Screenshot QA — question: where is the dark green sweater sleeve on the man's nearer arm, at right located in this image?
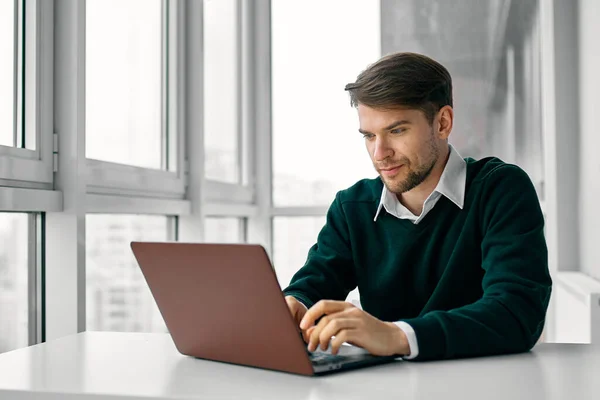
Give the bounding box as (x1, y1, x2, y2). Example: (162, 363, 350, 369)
(404, 165, 552, 360)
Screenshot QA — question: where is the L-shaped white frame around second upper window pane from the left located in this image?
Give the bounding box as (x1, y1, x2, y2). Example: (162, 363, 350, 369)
(80, 0, 187, 199)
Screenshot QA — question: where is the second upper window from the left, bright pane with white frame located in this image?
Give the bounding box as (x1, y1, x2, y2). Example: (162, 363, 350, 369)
(79, 0, 186, 199)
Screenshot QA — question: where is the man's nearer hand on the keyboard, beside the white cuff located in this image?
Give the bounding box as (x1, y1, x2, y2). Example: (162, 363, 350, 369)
(298, 300, 410, 356)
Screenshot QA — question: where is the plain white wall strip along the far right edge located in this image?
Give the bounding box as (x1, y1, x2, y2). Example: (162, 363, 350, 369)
(576, 0, 600, 279)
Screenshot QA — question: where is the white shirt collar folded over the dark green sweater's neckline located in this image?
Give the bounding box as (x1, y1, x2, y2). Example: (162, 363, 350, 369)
(373, 145, 467, 221)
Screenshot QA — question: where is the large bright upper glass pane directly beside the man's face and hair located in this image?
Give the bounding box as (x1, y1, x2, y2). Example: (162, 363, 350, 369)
(271, 0, 380, 206)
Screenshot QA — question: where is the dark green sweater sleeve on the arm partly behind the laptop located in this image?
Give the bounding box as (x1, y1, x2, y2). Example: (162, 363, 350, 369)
(283, 193, 356, 308)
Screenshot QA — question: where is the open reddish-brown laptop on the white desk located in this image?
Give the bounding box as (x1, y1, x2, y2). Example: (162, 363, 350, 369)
(131, 242, 397, 376)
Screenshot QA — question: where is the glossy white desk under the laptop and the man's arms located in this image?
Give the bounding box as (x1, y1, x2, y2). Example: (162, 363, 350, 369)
(0, 332, 600, 400)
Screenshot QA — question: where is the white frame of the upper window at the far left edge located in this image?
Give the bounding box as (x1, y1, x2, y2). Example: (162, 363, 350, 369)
(0, 0, 54, 189)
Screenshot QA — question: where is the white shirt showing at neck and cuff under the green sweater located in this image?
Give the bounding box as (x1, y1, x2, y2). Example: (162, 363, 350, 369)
(373, 145, 467, 360)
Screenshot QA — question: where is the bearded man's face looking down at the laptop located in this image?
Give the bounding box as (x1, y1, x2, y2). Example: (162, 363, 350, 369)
(358, 104, 441, 194)
